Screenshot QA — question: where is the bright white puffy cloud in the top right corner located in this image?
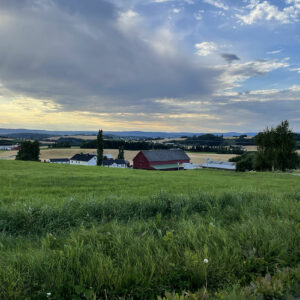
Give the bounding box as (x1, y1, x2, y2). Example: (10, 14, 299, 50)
(236, 0, 300, 25)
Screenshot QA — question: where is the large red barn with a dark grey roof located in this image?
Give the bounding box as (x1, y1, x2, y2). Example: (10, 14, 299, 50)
(133, 149, 190, 170)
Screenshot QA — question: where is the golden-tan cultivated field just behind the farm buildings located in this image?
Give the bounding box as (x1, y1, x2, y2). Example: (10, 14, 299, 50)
(0, 148, 235, 164)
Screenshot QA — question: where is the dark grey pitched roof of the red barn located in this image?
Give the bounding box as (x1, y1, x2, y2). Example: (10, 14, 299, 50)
(141, 149, 190, 162)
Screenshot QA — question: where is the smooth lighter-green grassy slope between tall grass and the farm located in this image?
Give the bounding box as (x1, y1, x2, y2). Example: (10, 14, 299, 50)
(0, 160, 300, 205)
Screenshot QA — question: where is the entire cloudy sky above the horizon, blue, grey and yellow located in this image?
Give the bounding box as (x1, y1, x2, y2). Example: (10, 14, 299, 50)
(0, 0, 300, 132)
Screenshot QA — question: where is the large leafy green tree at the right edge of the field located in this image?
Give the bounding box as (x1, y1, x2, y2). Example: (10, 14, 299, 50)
(255, 120, 298, 171)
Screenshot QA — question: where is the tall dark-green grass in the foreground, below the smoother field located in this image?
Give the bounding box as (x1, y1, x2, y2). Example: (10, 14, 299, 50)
(0, 192, 300, 299)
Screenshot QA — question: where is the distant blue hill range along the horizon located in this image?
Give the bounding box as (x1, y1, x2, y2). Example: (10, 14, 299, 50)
(0, 128, 257, 139)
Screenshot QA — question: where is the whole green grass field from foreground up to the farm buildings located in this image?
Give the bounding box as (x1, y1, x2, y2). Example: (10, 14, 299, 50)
(0, 160, 300, 300)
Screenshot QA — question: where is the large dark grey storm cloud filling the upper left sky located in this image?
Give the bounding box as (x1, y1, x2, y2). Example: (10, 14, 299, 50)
(0, 0, 221, 111)
